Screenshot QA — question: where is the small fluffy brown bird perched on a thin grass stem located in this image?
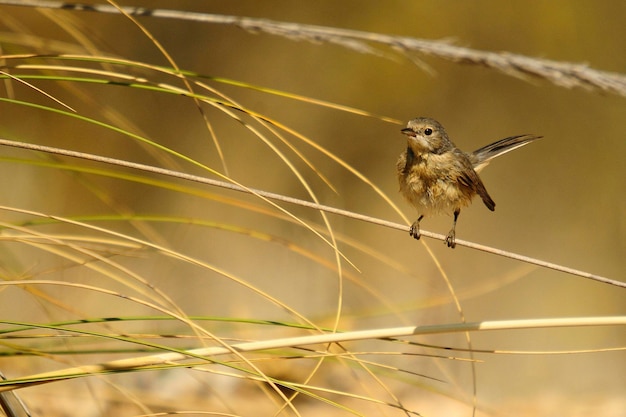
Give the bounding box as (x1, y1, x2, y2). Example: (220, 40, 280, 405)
(396, 117, 542, 248)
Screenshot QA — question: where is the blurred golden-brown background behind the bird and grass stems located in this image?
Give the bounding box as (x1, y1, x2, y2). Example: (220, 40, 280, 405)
(0, 0, 626, 416)
